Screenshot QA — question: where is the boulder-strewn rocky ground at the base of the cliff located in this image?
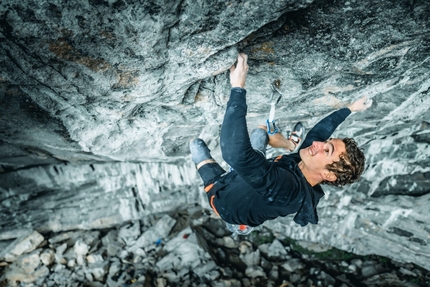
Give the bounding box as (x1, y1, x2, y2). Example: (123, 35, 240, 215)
(0, 205, 430, 287)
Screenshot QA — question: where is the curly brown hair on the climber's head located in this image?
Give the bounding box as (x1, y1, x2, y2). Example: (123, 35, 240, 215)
(321, 138, 366, 186)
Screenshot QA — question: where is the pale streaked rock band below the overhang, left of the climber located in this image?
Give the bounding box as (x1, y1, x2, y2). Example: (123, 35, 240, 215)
(0, 163, 206, 240)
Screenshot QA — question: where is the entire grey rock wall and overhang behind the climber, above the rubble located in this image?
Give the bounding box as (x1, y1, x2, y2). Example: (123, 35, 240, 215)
(0, 0, 430, 274)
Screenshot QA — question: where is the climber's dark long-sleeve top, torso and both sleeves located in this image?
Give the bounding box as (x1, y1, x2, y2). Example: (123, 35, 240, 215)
(214, 88, 351, 226)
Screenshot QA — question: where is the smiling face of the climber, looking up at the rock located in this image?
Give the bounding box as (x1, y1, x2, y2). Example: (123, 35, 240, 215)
(300, 139, 346, 180)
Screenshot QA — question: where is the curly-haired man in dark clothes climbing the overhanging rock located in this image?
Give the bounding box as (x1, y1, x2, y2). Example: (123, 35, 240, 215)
(190, 54, 371, 230)
